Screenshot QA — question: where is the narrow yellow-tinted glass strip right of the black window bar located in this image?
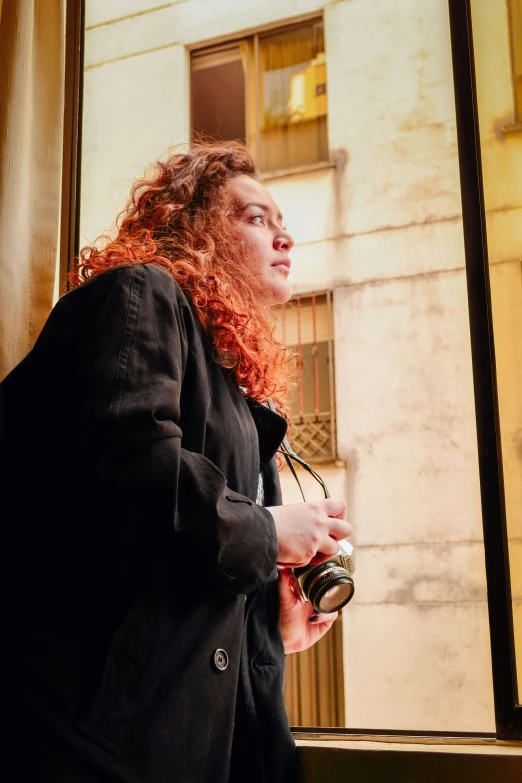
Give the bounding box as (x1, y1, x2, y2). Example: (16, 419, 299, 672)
(471, 0, 522, 698)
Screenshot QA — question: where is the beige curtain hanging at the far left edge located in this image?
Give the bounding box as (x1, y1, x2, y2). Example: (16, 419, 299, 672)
(0, 0, 66, 379)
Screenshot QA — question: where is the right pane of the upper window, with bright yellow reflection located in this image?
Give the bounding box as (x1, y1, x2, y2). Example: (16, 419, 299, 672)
(259, 22, 328, 171)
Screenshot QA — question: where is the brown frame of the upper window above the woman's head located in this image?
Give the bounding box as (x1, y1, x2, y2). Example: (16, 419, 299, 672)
(187, 12, 332, 179)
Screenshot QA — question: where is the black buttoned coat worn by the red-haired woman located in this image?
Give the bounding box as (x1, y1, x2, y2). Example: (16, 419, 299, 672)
(1, 265, 295, 783)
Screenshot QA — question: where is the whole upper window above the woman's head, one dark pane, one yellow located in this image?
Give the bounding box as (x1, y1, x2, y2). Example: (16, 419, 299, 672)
(191, 19, 328, 171)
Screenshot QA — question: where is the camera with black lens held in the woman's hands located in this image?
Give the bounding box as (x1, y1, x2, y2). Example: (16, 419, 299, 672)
(293, 539, 355, 613)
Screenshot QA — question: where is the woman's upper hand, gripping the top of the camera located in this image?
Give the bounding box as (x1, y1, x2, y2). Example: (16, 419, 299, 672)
(267, 498, 352, 568)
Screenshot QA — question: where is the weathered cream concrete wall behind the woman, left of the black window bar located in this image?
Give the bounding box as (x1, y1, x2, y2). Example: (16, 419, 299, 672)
(82, 0, 494, 731)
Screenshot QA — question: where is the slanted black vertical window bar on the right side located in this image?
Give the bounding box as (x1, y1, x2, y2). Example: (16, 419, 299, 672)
(448, 0, 522, 740)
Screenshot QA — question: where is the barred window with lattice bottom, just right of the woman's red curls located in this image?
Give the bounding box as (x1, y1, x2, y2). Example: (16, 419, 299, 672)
(278, 291, 336, 462)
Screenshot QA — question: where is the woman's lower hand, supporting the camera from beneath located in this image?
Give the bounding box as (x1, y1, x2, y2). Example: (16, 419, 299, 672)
(279, 568, 338, 653)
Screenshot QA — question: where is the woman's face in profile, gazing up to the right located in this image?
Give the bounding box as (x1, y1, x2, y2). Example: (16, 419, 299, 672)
(225, 174, 294, 306)
